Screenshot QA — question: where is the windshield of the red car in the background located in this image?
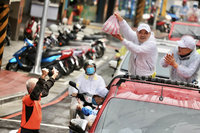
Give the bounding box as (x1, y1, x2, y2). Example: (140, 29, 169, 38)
(171, 24, 200, 40)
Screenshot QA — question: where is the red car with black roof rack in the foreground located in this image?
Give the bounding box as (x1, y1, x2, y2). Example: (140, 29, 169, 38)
(89, 75, 200, 133)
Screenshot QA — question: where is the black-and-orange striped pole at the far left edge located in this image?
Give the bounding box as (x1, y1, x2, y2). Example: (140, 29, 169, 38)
(0, 0, 9, 70)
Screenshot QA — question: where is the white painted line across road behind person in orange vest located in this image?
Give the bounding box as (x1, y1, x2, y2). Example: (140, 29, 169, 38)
(0, 118, 69, 129)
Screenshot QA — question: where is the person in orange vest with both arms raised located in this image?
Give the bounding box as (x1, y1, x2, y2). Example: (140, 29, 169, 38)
(17, 68, 58, 133)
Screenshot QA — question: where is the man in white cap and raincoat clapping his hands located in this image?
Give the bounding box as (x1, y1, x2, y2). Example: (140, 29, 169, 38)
(161, 35, 200, 83)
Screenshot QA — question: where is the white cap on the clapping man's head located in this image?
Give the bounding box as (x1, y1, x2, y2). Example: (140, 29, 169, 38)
(177, 35, 196, 50)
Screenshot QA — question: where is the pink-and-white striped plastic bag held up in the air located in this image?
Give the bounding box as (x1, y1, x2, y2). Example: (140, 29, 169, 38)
(102, 15, 119, 35)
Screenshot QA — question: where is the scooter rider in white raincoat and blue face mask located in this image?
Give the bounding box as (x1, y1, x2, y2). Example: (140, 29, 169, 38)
(69, 60, 108, 119)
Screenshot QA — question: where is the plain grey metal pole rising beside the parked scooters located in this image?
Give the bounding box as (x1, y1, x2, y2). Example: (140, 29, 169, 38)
(30, 0, 49, 75)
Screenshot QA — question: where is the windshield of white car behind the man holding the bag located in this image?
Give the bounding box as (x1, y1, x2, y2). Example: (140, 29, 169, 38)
(121, 52, 170, 78)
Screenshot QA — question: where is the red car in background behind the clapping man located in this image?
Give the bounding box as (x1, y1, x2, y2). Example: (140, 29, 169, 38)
(168, 22, 200, 47)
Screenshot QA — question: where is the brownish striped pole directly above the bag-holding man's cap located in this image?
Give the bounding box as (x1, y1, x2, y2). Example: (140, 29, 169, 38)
(133, 0, 145, 27)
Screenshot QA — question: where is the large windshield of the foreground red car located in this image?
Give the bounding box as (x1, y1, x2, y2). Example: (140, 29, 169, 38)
(95, 98, 200, 133)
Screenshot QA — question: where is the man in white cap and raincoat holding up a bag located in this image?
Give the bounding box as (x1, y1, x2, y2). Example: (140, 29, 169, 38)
(113, 13, 158, 76)
